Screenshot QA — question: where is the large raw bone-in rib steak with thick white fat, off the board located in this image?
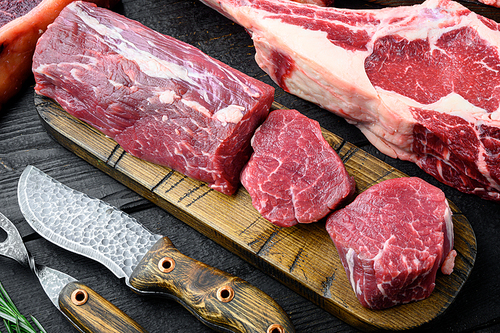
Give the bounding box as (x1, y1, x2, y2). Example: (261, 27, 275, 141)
(202, 0, 500, 200)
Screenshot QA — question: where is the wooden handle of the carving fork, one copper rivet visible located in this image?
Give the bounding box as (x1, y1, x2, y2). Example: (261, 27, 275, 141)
(59, 282, 147, 333)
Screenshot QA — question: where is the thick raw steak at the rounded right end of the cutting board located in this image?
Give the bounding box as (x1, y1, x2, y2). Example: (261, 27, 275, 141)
(326, 177, 456, 309)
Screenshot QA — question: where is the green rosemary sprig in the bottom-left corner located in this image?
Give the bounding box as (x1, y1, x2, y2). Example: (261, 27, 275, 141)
(0, 282, 47, 333)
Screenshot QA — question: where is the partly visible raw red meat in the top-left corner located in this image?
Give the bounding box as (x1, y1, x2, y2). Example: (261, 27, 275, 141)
(0, 0, 119, 111)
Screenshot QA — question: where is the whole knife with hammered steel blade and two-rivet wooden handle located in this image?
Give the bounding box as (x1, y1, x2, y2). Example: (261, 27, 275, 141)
(18, 166, 295, 333)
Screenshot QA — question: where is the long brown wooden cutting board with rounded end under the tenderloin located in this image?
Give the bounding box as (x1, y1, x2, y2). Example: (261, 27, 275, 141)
(35, 94, 476, 331)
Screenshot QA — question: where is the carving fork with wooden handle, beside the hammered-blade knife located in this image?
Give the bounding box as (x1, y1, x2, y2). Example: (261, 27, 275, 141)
(0, 213, 147, 333)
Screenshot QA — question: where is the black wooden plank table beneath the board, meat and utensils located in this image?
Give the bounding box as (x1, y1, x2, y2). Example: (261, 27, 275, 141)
(0, 0, 500, 333)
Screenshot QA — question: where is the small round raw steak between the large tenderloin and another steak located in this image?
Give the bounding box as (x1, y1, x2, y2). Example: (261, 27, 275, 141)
(241, 110, 355, 227)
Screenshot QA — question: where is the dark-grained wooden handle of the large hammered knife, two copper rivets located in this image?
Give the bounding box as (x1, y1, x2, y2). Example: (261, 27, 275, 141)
(129, 237, 295, 333)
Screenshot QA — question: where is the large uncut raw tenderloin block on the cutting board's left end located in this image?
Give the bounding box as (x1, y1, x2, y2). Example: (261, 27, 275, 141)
(33, 2, 274, 194)
